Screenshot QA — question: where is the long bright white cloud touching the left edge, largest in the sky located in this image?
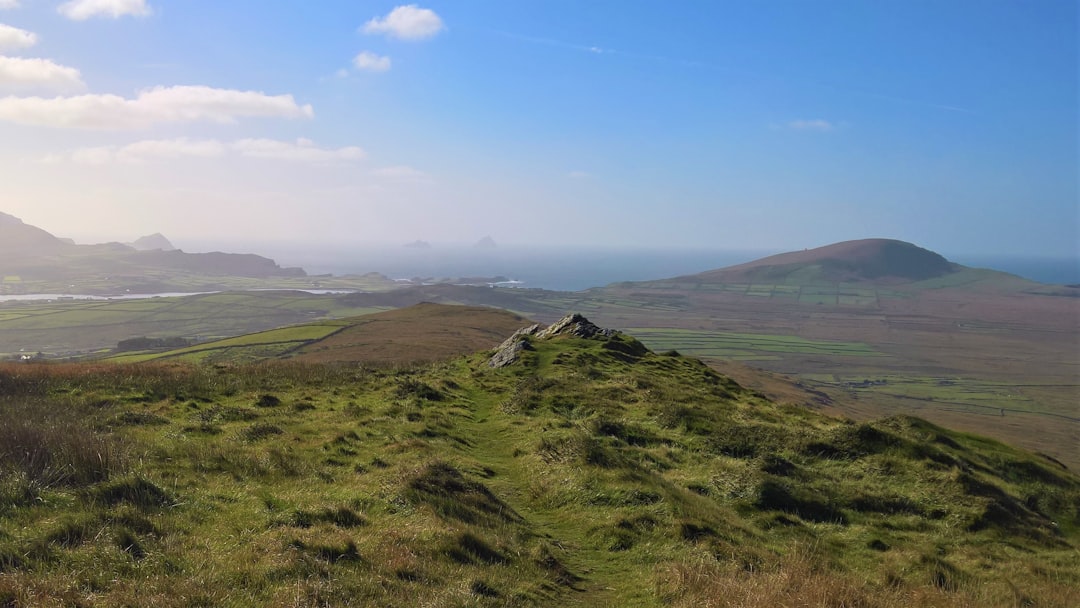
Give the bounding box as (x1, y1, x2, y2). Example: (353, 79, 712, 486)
(0, 85, 314, 129)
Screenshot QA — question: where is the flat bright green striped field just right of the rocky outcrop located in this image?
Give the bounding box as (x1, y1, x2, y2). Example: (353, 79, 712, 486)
(626, 327, 883, 361)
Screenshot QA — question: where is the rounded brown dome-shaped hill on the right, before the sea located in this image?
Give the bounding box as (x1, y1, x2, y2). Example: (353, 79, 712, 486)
(693, 239, 963, 283)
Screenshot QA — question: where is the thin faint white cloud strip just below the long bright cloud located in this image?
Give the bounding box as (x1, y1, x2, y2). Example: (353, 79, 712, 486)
(54, 137, 366, 165)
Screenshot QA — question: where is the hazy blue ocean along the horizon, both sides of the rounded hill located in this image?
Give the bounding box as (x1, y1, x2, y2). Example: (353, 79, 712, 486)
(256, 245, 1080, 292)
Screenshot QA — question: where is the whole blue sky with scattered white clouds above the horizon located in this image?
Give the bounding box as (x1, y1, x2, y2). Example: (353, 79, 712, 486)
(0, 0, 1080, 257)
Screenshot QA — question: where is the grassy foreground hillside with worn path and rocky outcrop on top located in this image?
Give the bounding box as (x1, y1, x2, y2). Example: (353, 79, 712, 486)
(0, 316, 1080, 608)
